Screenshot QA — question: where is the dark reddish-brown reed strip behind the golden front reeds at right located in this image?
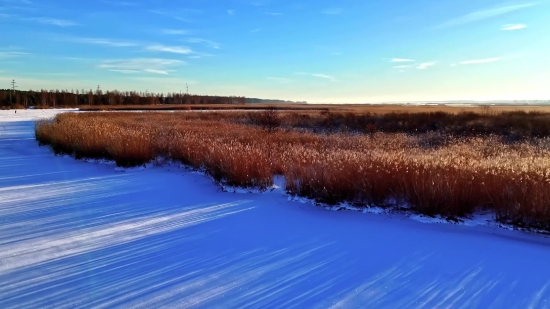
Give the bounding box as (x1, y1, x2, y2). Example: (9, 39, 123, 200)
(281, 109, 550, 137)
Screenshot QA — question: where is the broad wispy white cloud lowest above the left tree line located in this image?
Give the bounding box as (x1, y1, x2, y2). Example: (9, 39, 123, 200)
(97, 58, 185, 75)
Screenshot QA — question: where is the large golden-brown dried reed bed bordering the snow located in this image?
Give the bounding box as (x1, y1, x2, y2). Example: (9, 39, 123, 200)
(36, 113, 550, 230)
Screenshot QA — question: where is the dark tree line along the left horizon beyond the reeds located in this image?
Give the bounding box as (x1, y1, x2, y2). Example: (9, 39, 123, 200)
(0, 89, 246, 107)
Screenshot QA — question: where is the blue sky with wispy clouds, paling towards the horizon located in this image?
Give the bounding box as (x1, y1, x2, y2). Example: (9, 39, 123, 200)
(0, 0, 550, 103)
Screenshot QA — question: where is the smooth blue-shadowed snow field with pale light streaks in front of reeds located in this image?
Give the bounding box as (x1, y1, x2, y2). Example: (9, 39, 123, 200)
(0, 110, 550, 309)
